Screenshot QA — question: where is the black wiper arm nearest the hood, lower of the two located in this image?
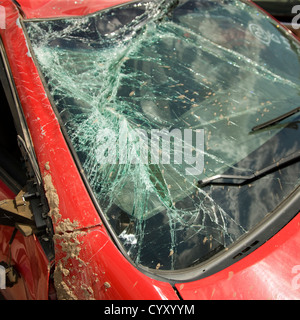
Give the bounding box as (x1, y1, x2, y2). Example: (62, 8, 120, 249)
(197, 151, 300, 188)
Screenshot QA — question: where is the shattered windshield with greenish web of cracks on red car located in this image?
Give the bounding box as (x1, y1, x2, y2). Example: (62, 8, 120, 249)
(24, 0, 300, 270)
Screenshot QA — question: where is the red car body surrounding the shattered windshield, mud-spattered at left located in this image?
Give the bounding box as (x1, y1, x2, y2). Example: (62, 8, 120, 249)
(0, 0, 300, 300)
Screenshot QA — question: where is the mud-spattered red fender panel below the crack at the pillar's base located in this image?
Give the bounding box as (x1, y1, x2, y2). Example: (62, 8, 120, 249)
(55, 227, 178, 300)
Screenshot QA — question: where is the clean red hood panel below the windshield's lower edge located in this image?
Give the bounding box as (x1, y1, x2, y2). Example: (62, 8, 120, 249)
(176, 214, 300, 300)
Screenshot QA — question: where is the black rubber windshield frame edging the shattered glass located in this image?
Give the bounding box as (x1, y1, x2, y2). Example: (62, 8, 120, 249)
(20, 0, 300, 283)
